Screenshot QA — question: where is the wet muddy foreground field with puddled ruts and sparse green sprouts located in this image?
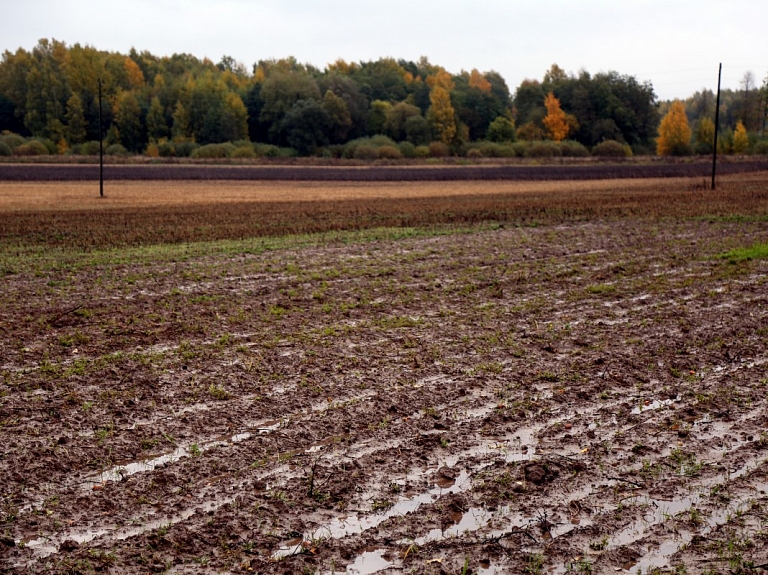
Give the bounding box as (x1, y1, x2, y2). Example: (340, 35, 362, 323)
(0, 178, 768, 574)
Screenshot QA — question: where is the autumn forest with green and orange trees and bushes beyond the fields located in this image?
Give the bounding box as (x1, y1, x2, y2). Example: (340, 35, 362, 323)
(0, 39, 768, 160)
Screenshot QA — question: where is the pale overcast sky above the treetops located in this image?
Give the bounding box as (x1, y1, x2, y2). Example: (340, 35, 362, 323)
(0, 0, 768, 99)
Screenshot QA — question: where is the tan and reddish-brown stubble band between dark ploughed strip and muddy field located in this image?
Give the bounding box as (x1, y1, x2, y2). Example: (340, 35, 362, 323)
(0, 172, 768, 249)
